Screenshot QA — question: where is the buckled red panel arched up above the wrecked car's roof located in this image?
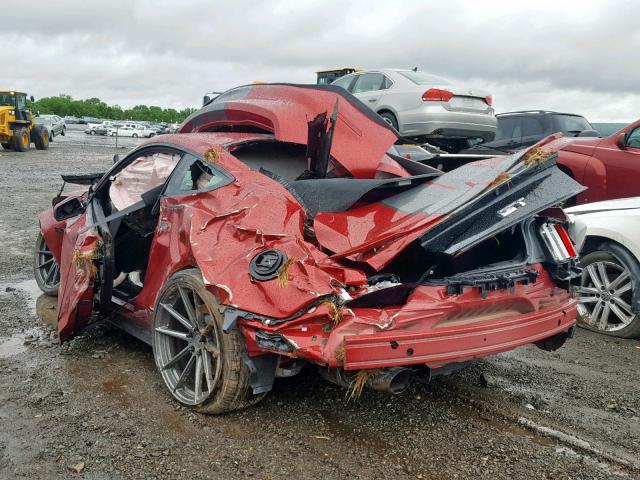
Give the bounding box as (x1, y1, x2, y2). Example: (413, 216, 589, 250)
(178, 84, 398, 178)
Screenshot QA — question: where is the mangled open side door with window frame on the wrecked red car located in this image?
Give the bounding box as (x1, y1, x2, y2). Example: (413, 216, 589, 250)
(58, 146, 184, 341)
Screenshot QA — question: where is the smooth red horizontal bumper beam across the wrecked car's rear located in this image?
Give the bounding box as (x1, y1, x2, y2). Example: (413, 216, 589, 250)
(344, 300, 577, 370)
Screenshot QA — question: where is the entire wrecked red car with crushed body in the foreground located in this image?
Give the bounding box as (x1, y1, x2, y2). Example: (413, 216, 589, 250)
(35, 84, 582, 413)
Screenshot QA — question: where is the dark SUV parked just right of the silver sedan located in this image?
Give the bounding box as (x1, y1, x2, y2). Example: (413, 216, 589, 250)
(460, 110, 599, 154)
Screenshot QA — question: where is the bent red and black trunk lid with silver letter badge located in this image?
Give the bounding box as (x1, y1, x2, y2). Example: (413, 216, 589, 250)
(314, 143, 584, 270)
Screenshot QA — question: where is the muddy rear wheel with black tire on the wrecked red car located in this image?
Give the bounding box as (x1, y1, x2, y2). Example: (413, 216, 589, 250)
(152, 269, 266, 414)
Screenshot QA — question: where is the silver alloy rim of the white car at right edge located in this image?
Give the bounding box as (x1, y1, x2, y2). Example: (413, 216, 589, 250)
(574, 261, 635, 332)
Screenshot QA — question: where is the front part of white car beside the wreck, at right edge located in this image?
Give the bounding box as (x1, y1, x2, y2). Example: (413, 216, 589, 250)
(567, 197, 640, 338)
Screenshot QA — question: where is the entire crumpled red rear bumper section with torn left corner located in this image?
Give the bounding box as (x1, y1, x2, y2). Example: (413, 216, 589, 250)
(242, 264, 577, 370)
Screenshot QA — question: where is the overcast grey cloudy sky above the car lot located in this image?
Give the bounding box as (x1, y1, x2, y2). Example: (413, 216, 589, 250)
(0, 0, 640, 122)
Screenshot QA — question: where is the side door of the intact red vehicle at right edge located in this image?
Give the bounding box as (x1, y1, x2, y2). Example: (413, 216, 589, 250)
(593, 125, 640, 199)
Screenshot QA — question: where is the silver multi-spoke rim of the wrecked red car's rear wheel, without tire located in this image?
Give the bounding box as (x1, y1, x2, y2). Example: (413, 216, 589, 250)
(153, 282, 222, 405)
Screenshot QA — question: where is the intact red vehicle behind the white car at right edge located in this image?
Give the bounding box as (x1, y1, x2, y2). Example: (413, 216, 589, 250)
(554, 120, 640, 204)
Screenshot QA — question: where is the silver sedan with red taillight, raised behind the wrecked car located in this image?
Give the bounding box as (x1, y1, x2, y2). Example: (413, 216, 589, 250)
(332, 69, 496, 151)
